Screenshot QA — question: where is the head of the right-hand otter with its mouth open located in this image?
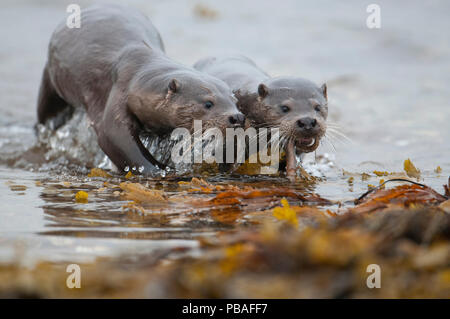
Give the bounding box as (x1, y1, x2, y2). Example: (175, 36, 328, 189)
(236, 77, 328, 153)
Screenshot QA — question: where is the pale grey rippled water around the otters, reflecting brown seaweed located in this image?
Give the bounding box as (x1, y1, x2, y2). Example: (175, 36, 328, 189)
(0, 0, 450, 264)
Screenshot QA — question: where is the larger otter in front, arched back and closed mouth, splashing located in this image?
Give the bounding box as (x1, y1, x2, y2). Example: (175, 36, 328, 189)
(37, 5, 244, 174)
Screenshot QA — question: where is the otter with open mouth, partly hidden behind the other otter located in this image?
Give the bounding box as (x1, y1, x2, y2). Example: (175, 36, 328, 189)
(194, 55, 328, 177)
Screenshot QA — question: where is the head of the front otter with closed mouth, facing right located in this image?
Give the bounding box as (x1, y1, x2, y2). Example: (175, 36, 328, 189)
(128, 70, 245, 133)
